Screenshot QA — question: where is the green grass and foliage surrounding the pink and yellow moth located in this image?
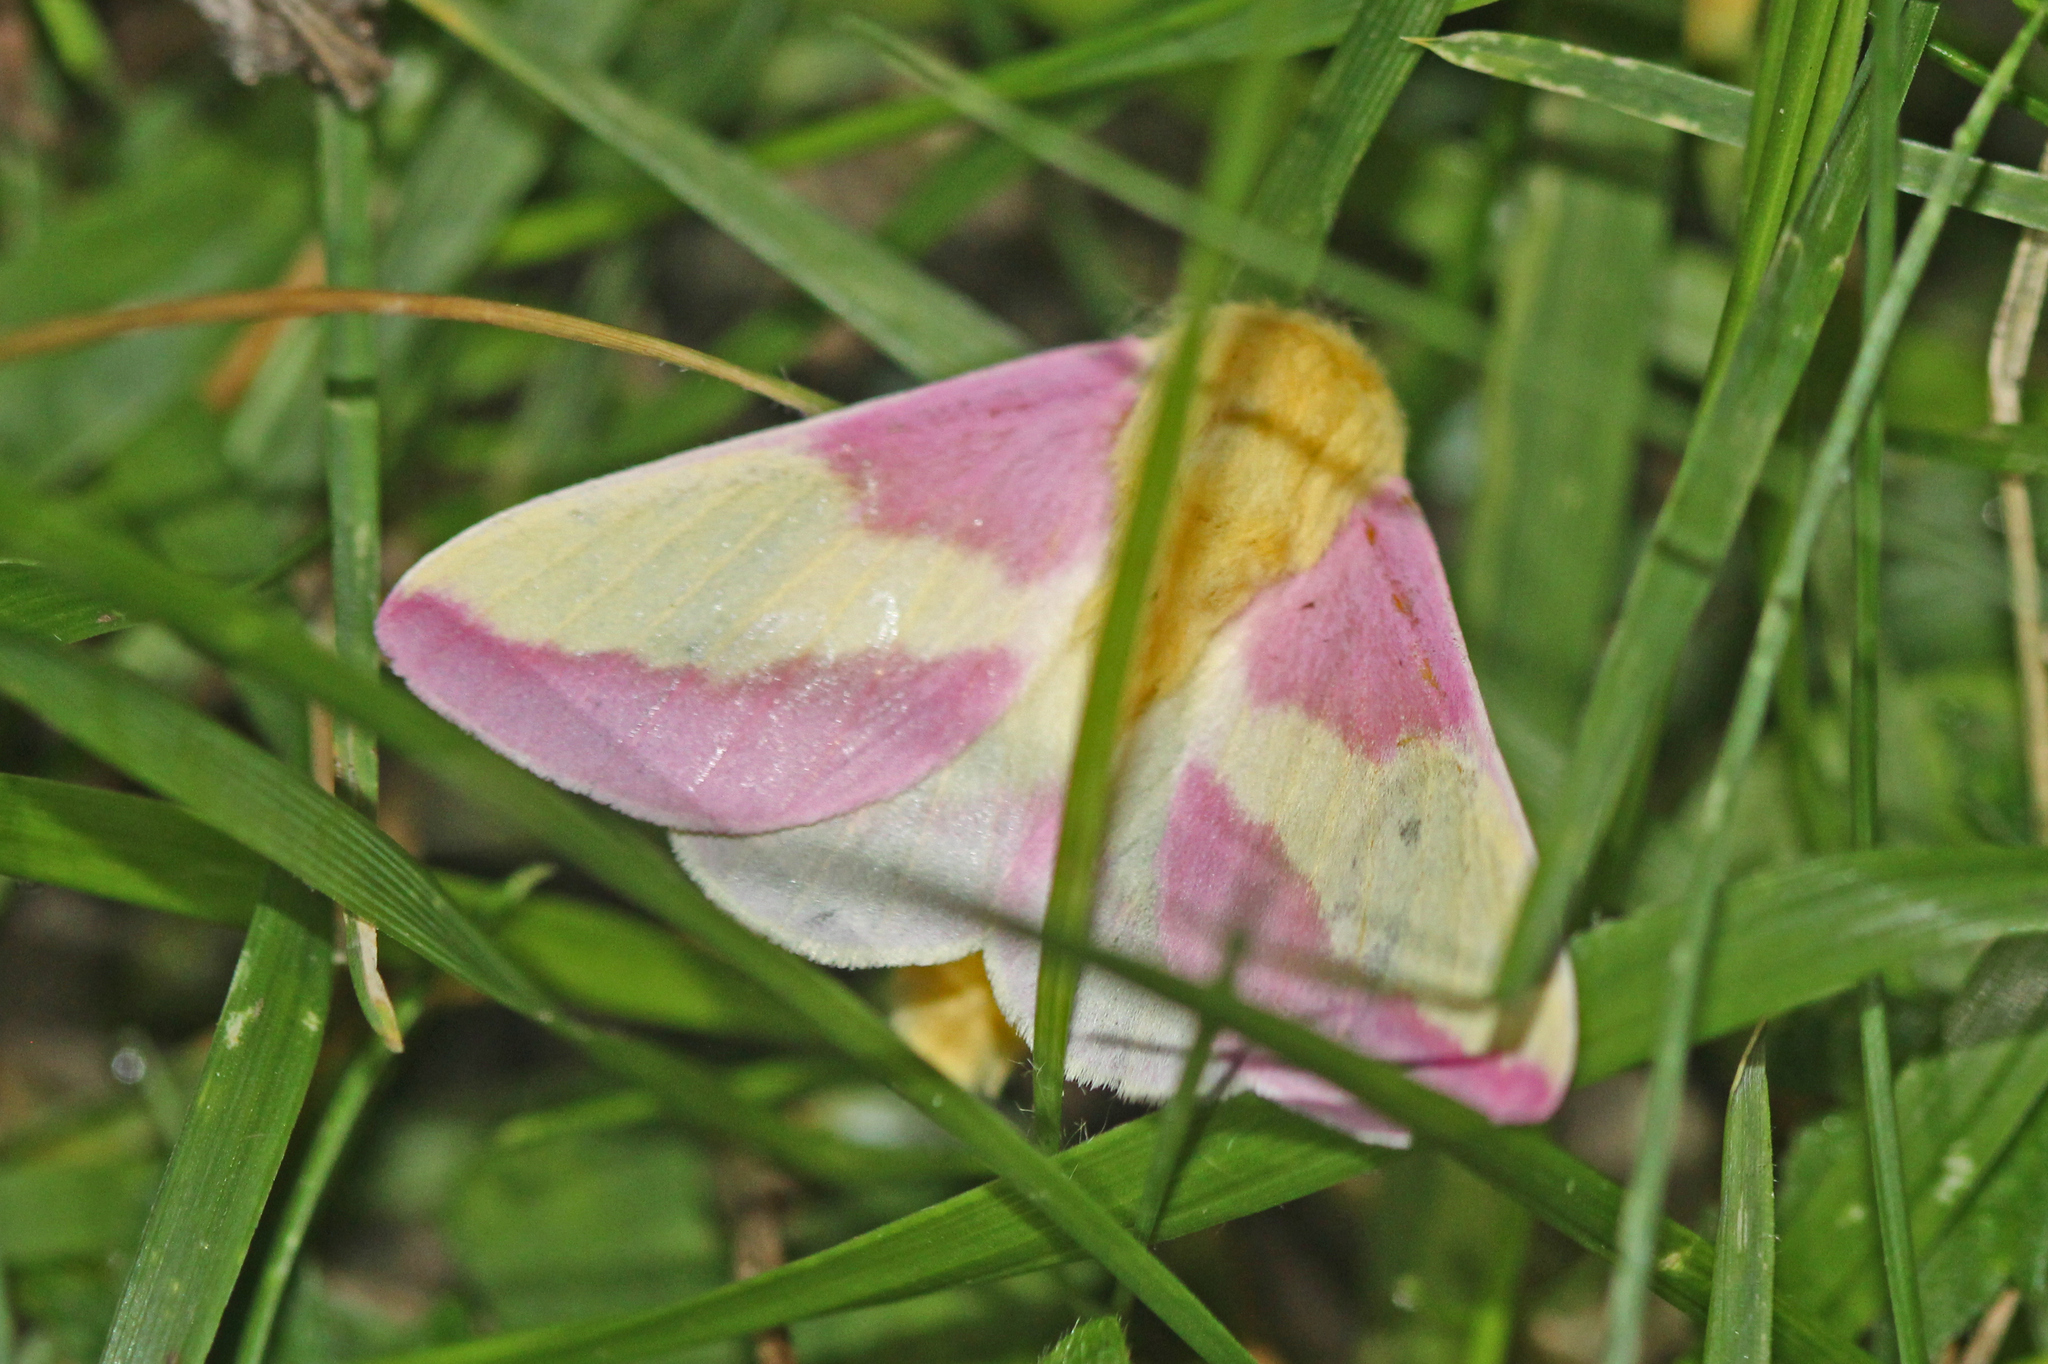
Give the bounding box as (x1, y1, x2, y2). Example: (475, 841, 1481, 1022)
(0, 0, 2048, 1364)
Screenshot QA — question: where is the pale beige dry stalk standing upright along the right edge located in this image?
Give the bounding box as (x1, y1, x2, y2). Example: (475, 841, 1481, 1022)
(1987, 140, 2048, 842)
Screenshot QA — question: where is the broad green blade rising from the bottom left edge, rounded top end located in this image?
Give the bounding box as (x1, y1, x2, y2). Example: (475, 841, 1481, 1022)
(100, 872, 334, 1364)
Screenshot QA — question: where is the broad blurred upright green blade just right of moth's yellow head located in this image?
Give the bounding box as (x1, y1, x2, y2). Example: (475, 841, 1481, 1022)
(1458, 94, 1677, 739)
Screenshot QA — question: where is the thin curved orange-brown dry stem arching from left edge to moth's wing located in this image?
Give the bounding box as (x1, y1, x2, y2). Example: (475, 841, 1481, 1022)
(0, 289, 838, 416)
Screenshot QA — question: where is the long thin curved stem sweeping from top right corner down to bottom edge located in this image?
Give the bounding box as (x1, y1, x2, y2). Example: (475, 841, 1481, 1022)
(1606, 8, 2048, 1364)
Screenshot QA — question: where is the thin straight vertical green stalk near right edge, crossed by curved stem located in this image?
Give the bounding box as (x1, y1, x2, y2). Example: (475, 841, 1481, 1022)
(1849, 0, 1927, 1364)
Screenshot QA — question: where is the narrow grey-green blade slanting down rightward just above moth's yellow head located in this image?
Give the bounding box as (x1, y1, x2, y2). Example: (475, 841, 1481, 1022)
(840, 18, 1485, 358)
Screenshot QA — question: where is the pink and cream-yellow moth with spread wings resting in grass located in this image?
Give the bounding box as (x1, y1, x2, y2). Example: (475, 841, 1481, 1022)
(377, 305, 1577, 1141)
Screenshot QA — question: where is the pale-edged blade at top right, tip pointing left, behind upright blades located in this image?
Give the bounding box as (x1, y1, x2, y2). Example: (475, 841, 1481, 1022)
(1423, 20, 2048, 227)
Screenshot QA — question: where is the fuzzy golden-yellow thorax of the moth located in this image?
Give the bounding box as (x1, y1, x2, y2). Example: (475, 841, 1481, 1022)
(1114, 303, 1407, 717)
